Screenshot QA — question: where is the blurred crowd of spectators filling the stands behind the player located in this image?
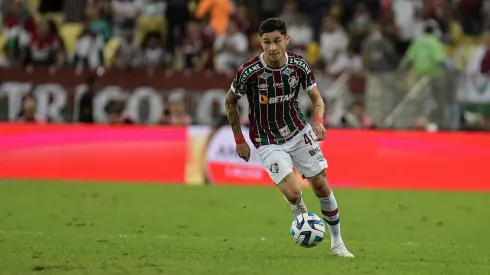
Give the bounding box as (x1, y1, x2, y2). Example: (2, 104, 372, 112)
(0, 0, 490, 133)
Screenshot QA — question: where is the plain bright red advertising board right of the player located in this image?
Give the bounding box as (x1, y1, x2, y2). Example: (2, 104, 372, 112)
(322, 130, 490, 191)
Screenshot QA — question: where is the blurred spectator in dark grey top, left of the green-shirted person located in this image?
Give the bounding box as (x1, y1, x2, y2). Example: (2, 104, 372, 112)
(362, 25, 398, 125)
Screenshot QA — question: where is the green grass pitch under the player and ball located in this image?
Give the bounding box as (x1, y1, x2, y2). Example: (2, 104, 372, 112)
(0, 181, 490, 275)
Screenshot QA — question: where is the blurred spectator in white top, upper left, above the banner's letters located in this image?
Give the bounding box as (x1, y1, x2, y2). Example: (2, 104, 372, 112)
(73, 23, 105, 70)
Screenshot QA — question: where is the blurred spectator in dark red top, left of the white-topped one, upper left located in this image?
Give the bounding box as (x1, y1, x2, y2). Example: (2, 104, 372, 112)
(20, 20, 64, 68)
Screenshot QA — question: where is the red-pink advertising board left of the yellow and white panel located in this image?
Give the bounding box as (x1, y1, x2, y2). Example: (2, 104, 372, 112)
(0, 124, 187, 184)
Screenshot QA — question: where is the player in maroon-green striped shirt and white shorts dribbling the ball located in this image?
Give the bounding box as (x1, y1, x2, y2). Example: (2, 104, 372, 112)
(226, 18, 354, 257)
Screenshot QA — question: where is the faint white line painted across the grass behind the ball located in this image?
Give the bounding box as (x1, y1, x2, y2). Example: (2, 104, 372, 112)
(0, 230, 478, 248)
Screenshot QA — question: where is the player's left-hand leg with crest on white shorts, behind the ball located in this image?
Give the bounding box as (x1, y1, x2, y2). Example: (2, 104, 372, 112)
(257, 145, 308, 217)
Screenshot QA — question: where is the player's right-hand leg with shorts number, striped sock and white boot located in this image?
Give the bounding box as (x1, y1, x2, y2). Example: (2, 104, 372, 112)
(289, 125, 353, 257)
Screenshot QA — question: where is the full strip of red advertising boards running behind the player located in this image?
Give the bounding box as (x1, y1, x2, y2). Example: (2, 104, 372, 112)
(0, 124, 490, 191)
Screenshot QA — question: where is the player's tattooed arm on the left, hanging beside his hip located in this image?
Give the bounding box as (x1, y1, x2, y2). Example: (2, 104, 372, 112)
(225, 74, 250, 161)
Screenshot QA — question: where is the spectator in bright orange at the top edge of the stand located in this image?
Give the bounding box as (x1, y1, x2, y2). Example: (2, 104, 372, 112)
(196, 0, 234, 36)
